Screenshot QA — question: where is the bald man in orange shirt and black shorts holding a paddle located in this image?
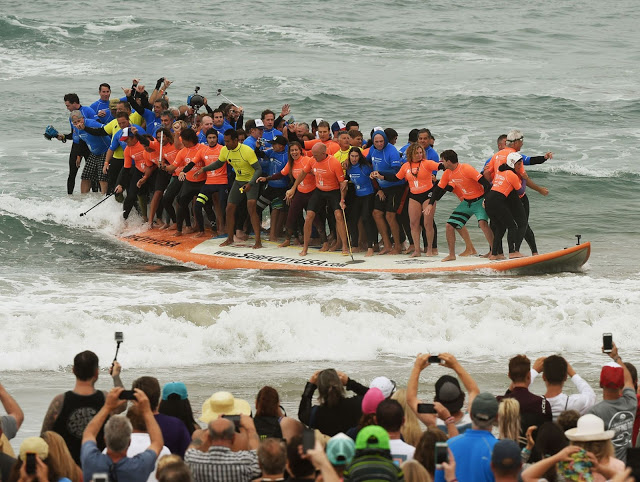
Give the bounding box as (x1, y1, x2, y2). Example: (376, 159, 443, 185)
(287, 143, 349, 256)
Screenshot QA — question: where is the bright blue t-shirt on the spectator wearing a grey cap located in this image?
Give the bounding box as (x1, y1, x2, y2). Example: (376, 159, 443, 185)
(435, 429, 498, 482)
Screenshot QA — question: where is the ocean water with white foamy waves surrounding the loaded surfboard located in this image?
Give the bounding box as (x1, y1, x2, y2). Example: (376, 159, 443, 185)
(0, 0, 640, 444)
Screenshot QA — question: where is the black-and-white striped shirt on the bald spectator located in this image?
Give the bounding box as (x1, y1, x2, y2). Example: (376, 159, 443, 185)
(184, 446, 262, 482)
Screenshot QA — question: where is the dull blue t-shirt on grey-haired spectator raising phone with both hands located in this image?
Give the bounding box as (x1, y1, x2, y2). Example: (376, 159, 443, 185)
(80, 440, 157, 482)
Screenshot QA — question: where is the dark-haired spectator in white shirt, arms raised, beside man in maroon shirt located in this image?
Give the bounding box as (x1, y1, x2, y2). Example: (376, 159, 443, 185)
(531, 355, 596, 422)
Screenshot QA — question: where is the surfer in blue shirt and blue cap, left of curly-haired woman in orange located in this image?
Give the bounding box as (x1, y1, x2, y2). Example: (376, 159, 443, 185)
(367, 130, 406, 254)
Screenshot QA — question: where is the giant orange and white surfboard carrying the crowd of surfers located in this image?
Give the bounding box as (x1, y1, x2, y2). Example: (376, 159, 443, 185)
(120, 229, 591, 274)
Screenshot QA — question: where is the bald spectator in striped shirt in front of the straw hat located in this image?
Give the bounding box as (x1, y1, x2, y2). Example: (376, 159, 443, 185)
(184, 415, 262, 482)
